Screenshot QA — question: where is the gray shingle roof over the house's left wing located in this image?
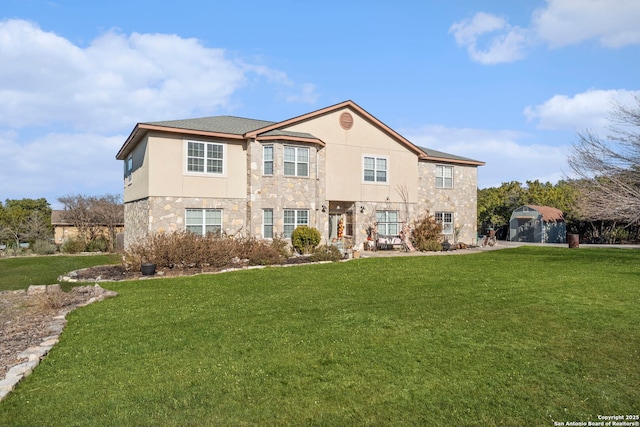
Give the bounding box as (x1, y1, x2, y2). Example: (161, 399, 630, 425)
(145, 116, 275, 135)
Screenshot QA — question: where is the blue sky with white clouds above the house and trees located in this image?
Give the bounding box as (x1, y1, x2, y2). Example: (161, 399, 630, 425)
(0, 0, 640, 208)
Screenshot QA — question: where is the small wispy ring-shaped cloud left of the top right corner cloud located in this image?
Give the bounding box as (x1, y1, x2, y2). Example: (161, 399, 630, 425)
(449, 12, 528, 64)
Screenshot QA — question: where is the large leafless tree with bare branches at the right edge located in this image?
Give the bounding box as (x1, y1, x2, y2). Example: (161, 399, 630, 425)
(569, 96, 640, 225)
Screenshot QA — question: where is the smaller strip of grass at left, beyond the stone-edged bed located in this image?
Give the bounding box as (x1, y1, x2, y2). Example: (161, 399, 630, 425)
(0, 254, 122, 291)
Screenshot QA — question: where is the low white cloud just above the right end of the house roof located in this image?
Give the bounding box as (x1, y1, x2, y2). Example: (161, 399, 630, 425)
(403, 125, 569, 188)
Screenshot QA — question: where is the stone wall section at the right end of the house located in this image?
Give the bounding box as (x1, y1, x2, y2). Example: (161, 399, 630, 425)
(417, 162, 478, 244)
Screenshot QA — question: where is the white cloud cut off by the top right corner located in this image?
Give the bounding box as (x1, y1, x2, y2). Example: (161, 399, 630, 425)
(533, 0, 640, 48)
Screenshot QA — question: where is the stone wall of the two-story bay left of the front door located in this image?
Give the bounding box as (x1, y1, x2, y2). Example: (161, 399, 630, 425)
(247, 140, 328, 238)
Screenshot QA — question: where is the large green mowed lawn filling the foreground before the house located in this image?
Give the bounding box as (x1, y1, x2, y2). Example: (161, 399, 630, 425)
(0, 247, 640, 426)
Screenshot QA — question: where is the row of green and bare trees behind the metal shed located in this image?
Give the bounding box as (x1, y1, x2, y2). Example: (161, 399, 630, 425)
(478, 97, 640, 243)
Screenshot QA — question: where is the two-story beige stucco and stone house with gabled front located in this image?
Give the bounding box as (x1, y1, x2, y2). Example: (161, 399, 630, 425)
(116, 101, 484, 251)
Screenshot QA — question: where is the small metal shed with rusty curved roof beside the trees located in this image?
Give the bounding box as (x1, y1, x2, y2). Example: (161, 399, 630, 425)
(509, 205, 567, 243)
